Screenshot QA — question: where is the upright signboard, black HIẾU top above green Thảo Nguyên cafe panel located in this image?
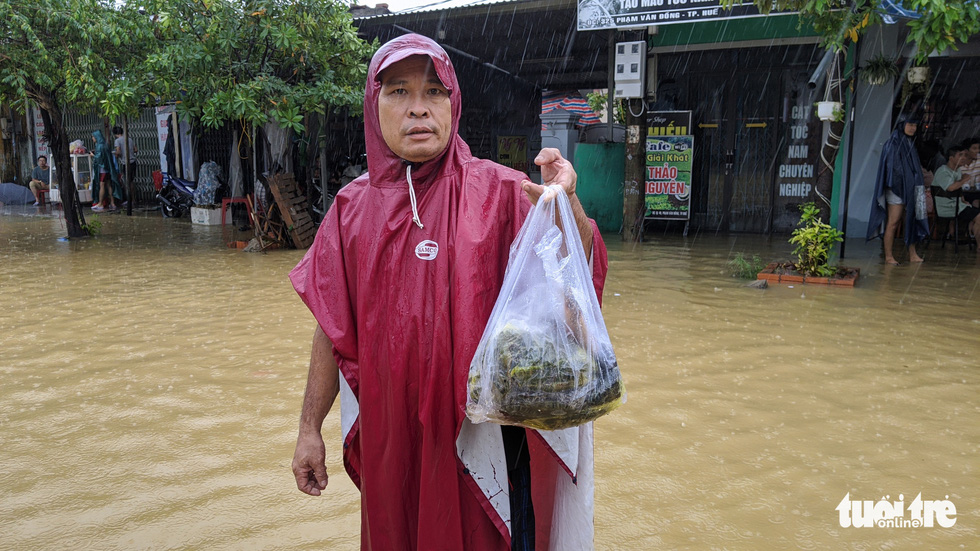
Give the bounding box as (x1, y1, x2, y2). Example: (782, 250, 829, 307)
(646, 111, 694, 220)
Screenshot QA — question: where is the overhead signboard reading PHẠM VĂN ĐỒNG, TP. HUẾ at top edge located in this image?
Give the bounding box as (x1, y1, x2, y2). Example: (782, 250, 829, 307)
(578, 0, 791, 31)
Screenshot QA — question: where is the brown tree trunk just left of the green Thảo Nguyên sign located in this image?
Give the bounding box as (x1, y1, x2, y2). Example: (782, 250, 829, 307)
(624, 99, 647, 243)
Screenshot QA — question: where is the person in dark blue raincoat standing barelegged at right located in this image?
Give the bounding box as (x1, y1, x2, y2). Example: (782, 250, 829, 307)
(867, 116, 929, 265)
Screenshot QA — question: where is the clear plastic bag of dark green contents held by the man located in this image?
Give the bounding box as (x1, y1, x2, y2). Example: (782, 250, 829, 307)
(466, 186, 626, 430)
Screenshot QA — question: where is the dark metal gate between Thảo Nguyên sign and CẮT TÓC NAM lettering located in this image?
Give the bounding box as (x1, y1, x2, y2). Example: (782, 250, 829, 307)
(659, 45, 817, 233)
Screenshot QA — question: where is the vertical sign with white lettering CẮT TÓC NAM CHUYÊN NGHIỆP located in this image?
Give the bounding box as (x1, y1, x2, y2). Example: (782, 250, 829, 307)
(772, 92, 821, 232)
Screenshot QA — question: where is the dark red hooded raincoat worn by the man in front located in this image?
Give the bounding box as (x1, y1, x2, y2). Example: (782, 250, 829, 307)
(290, 35, 606, 551)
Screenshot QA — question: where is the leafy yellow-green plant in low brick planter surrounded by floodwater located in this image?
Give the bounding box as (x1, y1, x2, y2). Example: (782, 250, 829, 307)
(757, 202, 860, 287)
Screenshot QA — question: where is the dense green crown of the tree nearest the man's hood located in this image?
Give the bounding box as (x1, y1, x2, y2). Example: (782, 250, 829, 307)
(144, 0, 374, 136)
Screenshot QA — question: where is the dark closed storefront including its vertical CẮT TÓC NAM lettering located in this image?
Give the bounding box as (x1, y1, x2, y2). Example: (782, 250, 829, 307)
(651, 32, 823, 233)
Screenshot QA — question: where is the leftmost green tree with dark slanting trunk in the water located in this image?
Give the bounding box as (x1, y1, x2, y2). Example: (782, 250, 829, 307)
(0, 0, 152, 237)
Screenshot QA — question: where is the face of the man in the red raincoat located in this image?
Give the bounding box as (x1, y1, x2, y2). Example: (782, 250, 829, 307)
(378, 55, 453, 163)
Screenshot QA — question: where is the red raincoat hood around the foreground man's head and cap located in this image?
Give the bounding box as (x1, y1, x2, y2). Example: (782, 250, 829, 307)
(364, 34, 472, 188)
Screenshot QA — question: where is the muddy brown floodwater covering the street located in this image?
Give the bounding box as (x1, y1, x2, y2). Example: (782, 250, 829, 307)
(0, 207, 980, 551)
